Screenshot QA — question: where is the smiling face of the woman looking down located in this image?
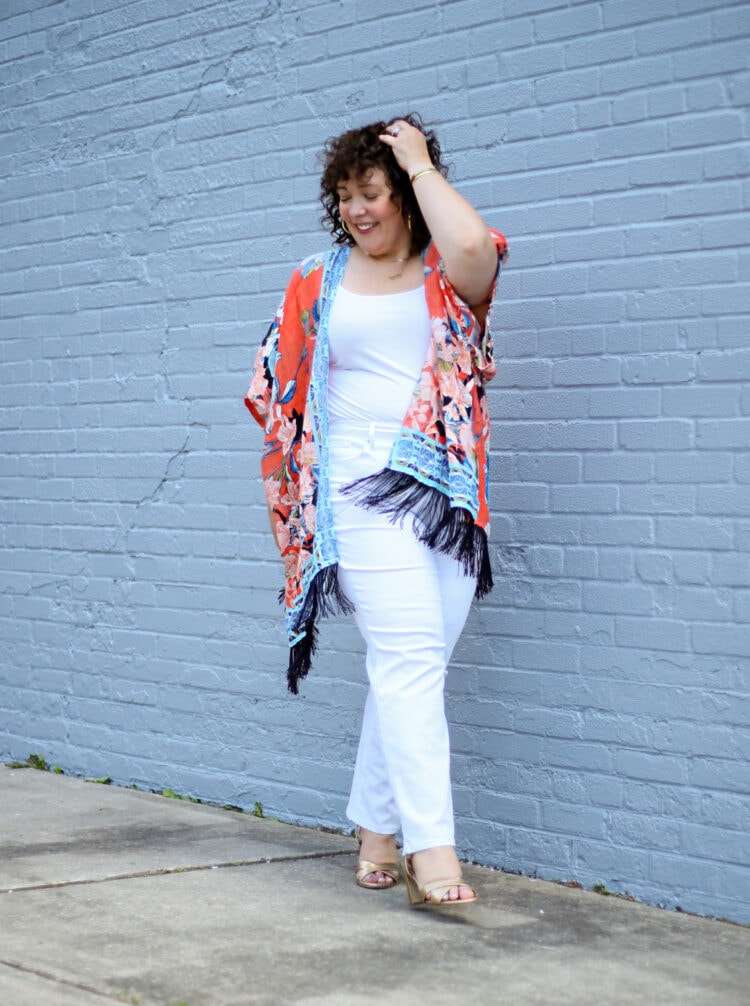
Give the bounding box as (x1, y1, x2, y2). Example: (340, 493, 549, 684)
(338, 168, 411, 258)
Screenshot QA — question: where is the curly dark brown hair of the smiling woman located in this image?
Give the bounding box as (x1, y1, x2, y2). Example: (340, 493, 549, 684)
(321, 113, 447, 255)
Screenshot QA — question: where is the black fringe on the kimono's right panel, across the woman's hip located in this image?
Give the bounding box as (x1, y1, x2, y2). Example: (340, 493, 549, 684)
(341, 468, 493, 598)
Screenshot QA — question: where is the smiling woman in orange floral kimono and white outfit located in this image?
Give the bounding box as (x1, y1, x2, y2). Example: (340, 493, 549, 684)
(245, 116, 507, 907)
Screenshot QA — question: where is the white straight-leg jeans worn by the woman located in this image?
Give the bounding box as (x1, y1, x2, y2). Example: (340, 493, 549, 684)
(330, 424, 476, 853)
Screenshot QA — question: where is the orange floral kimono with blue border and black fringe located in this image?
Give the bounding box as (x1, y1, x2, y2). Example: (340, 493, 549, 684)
(245, 231, 508, 694)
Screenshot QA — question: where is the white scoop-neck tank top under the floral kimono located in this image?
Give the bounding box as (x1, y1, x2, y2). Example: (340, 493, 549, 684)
(328, 285, 431, 424)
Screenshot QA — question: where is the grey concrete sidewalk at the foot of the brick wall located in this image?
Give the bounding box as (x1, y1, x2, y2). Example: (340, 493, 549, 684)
(0, 767, 750, 1006)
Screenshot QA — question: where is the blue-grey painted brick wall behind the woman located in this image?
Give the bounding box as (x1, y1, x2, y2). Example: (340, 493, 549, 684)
(0, 0, 750, 921)
